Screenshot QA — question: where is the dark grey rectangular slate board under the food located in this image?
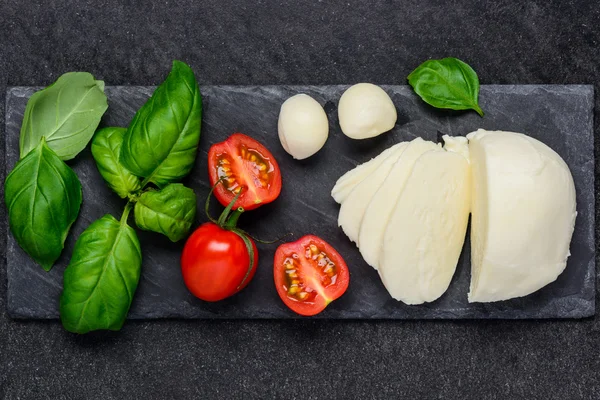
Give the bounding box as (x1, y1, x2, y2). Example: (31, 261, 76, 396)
(6, 85, 595, 319)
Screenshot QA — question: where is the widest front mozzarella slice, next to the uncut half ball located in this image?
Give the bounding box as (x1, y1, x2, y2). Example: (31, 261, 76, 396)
(379, 150, 471, 304)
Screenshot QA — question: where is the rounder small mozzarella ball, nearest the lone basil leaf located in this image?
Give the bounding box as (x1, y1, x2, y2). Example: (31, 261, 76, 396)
(338, 83, 397, 139)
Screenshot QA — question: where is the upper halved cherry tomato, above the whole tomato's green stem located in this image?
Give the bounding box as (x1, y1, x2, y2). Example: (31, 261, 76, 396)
(208, 133, 281, 211)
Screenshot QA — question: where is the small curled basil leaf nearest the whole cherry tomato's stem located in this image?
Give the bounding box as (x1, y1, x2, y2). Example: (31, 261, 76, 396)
(135, 183, 196, 242)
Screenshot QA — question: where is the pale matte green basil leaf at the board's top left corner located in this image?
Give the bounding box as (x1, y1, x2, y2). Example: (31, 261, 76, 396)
(20, 72, 108, 160)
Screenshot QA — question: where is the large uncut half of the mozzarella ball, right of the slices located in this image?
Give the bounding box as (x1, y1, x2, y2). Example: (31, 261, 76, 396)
(467, 129, 577, 302)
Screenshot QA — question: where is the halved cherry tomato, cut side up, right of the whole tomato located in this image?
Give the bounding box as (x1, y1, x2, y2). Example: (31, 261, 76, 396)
(273, 235, 350, 316)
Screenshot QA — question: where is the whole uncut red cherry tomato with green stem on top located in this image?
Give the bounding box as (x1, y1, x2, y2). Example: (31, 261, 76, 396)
(181, 222, 258, 301)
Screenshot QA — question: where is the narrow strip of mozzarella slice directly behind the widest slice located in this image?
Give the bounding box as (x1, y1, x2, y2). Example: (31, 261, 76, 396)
(358, 138, 438, 269)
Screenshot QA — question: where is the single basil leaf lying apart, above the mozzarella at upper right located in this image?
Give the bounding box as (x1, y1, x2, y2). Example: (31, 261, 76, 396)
(408, 57, 483, 117)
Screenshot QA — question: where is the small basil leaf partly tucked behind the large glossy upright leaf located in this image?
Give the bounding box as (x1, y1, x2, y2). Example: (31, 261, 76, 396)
(92, 127, 142, 199)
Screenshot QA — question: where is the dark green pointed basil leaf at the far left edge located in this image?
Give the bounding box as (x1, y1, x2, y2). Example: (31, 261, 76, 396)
(4, 138, 81, 271)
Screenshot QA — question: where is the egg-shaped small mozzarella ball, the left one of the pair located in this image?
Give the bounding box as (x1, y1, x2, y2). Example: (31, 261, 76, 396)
(277, 94, 329, 160)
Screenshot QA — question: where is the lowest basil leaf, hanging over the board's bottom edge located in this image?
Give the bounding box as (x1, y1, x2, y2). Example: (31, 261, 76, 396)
(60, 211, 142, 333)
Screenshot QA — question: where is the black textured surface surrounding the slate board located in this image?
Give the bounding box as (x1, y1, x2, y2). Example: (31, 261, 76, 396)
(0, 0, 600, 399)
